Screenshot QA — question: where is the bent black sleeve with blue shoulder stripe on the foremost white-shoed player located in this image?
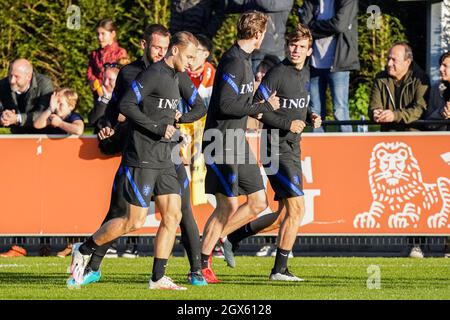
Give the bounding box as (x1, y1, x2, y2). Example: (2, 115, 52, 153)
(119, 72, 167, 137)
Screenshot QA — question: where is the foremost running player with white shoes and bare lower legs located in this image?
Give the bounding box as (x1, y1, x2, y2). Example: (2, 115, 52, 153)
(71, 32, 202, 290)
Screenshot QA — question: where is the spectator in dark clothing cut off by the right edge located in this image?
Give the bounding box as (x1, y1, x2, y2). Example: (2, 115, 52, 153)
(425, 52, 450, 131)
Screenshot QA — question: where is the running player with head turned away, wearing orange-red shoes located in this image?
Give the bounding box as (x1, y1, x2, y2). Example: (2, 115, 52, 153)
(201, 11, 279, 283)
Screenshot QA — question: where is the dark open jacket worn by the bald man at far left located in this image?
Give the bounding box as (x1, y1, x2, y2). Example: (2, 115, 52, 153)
(0, 72, 53, 133)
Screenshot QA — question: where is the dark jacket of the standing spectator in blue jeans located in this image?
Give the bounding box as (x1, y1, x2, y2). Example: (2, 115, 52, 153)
(299, 0, 360, 72)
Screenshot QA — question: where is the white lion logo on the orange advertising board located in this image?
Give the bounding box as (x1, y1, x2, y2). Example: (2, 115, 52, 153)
(353, 142, 450, 229)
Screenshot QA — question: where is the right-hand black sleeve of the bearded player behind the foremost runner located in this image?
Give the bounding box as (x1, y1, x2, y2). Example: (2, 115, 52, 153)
(178, 72, 206, 123)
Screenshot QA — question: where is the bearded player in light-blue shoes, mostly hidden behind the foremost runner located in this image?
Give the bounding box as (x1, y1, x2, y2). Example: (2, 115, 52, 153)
(68, 24, 207, 286)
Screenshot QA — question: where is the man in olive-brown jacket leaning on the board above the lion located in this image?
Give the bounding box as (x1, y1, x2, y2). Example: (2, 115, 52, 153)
(369, 42, 429, 131)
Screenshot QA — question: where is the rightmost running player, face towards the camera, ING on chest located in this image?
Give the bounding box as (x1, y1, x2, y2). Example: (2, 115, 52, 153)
(224, 24, 321, 281)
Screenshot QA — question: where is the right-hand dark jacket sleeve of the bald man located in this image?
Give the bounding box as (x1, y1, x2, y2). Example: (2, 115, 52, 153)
(20, 76, 53, 127)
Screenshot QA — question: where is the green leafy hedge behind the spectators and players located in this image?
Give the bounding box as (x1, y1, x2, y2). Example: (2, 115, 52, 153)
(0, 0, 403, 118)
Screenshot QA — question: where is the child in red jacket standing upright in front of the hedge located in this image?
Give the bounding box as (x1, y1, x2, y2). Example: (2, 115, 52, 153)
(87, 19, 128, 102)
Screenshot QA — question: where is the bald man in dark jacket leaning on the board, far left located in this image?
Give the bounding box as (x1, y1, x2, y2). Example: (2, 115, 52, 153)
(0, 59, 53, 134)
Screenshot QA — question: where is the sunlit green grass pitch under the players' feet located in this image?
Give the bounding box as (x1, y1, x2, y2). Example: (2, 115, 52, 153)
(0, 256, 450, 300)
